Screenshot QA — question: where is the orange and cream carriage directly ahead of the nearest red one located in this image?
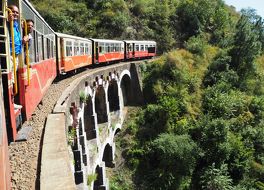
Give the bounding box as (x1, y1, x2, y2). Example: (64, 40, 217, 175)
(56, 33, 92, 74)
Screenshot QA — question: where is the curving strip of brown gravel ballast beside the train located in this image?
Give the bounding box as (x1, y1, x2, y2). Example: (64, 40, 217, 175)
(9, 69, 93, 190)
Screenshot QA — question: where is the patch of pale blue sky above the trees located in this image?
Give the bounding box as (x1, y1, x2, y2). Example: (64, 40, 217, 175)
(224, 0, 264, 18)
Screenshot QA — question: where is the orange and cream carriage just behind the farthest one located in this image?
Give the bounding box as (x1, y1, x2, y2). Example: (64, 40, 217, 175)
(91, 38, 125, 64)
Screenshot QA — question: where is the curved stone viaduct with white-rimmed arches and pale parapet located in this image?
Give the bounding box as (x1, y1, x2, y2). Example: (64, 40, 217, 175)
(40, 63, 143, 190)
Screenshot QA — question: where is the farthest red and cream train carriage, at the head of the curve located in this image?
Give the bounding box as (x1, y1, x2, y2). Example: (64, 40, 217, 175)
(124, 40, 156, 60)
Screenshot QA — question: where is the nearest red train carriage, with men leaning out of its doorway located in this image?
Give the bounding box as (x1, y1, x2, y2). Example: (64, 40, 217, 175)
(1, 0, 56, 141)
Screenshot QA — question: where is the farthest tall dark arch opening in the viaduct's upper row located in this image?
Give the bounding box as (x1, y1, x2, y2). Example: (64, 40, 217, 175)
(120, 74, 133, 106)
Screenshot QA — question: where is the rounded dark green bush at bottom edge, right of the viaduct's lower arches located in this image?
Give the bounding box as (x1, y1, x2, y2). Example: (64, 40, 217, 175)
(139, 134, 199, 189)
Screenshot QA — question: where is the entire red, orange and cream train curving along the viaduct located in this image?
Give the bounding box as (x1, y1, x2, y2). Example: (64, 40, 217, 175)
(0, 0, 156, 189)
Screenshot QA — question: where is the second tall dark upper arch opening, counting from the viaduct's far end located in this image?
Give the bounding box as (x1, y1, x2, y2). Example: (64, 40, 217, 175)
(107, 80, 120, 112)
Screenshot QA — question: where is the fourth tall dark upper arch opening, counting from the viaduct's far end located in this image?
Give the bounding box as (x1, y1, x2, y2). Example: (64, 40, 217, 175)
(83, 95, 96, 140)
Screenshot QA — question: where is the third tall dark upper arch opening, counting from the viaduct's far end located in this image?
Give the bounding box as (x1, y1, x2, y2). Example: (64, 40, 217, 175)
(95, 86, 108, 124)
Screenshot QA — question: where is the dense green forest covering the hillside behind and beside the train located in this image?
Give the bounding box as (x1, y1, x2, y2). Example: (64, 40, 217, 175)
(32, 0, 264, 190)
